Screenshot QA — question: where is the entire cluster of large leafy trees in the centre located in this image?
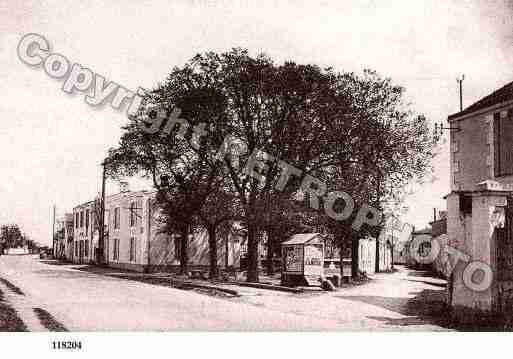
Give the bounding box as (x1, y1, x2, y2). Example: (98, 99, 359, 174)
(106, 49, 436, 282)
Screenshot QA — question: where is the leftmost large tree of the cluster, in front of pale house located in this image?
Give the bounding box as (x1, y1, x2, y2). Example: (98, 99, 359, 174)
(106, 57, 231, 274)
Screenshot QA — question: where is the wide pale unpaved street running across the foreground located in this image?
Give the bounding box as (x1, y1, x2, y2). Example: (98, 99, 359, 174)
(0, 256, 447, 331)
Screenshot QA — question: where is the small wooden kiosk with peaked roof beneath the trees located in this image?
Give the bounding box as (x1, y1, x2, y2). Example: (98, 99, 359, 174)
(281, 233, 324, 287)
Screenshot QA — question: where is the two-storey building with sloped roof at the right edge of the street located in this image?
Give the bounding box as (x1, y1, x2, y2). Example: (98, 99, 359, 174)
(446, 83, 513, 311)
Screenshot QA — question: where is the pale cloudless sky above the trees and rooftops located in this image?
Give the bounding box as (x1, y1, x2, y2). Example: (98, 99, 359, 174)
(0, 0, 513, 244)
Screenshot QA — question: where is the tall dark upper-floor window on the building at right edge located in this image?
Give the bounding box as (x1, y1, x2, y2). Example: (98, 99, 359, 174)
(493, 110, 513, 177)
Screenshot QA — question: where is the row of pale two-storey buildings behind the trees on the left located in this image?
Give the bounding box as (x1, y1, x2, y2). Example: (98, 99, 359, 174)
(67, 188, 246, 271)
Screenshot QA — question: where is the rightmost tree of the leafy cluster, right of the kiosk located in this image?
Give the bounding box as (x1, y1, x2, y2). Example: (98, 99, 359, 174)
(312, 70, 437, 277)
